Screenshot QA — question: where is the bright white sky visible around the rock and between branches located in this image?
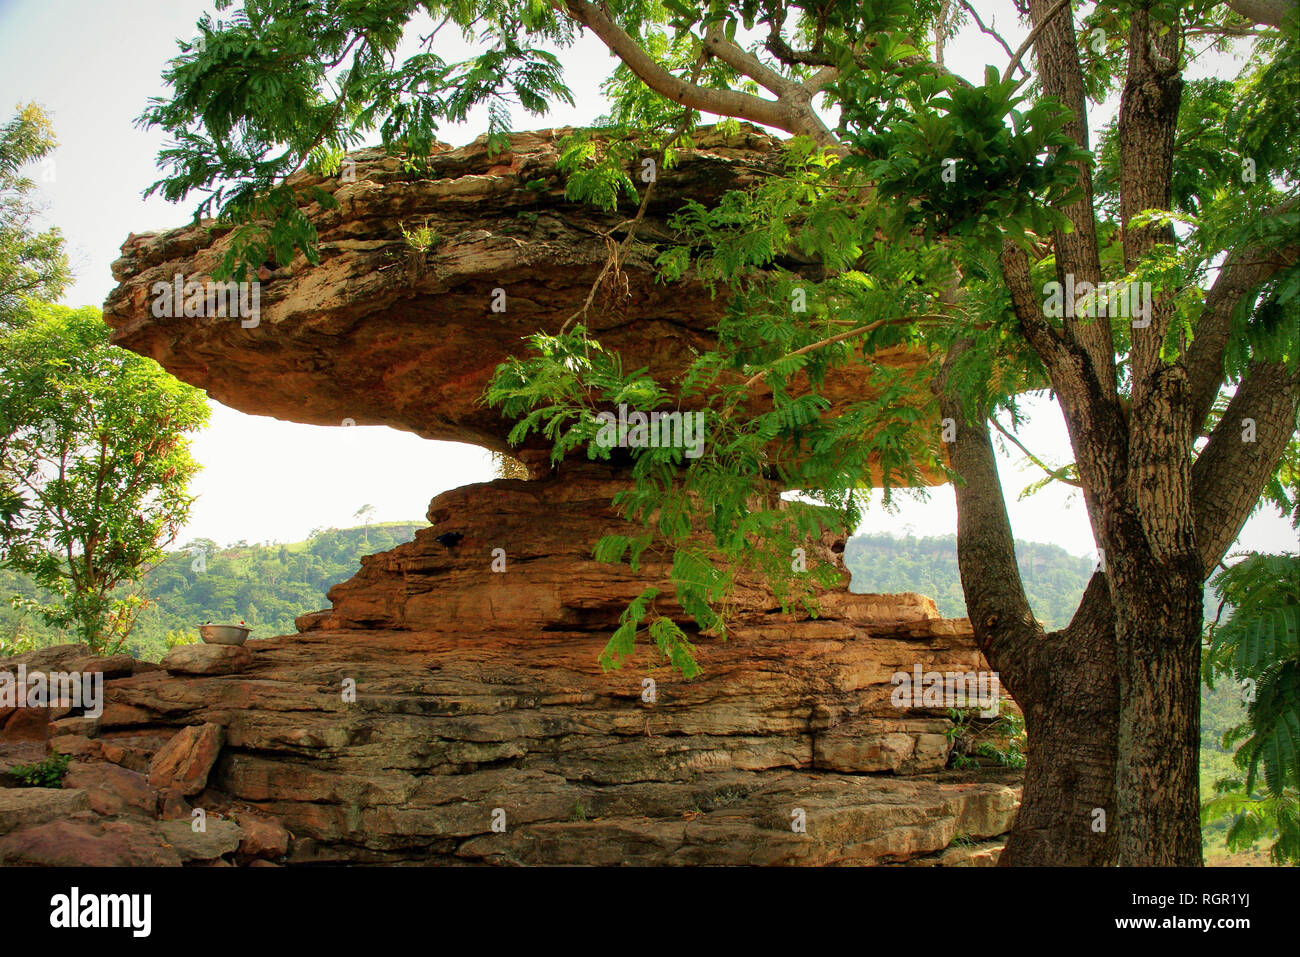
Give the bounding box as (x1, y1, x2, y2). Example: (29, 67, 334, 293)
(0, 0, 1296, 555)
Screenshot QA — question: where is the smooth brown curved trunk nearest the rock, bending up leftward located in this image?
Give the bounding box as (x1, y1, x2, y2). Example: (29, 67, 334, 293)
(935, 342, 1118, 866)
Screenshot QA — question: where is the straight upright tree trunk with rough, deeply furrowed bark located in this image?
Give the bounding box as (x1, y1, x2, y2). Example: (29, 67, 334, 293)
(1104, 10, 1205, 867)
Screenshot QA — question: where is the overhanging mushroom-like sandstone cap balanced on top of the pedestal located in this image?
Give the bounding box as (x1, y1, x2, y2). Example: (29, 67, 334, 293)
(104, 126, 922, 465)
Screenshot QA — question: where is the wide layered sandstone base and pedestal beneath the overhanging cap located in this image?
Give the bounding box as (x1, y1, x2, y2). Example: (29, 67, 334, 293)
(0, 467, 1018, 865)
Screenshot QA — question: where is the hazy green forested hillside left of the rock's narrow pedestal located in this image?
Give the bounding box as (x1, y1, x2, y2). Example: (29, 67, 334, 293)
(0, 523, 424, 661)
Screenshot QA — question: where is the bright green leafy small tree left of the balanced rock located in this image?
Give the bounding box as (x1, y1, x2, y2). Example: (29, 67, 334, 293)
(0, 300, 208, 651)
